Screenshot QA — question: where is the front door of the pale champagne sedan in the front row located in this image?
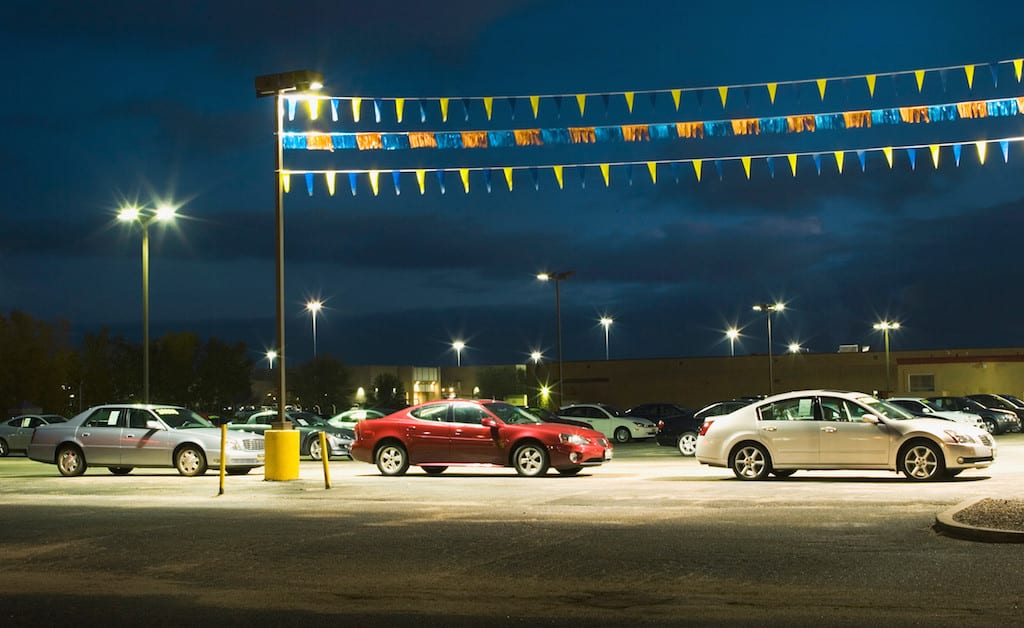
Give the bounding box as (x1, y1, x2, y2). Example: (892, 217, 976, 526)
(820, 396, 891, 467)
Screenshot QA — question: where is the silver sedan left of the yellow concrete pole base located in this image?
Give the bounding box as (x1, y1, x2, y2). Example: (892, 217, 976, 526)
(29, 404, 264, 476)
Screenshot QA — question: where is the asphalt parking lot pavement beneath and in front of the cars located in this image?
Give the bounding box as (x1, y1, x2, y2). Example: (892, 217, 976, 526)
(0, 434, 1024, 626)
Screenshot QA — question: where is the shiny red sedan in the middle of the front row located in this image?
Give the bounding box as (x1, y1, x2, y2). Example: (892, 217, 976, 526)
(352, 400, 611, 476)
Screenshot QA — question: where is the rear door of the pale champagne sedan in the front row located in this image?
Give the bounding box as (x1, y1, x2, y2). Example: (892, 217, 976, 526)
(758, 396, 821, 465)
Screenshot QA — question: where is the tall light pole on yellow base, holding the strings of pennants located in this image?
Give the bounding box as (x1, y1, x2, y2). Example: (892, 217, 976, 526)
(254, 70, 324, 430)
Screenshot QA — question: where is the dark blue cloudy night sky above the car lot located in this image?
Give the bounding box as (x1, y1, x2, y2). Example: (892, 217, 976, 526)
(0, 0, 1024, 366)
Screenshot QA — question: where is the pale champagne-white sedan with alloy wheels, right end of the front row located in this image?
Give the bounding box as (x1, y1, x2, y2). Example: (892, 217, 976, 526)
(696, 390, 995, 480)
